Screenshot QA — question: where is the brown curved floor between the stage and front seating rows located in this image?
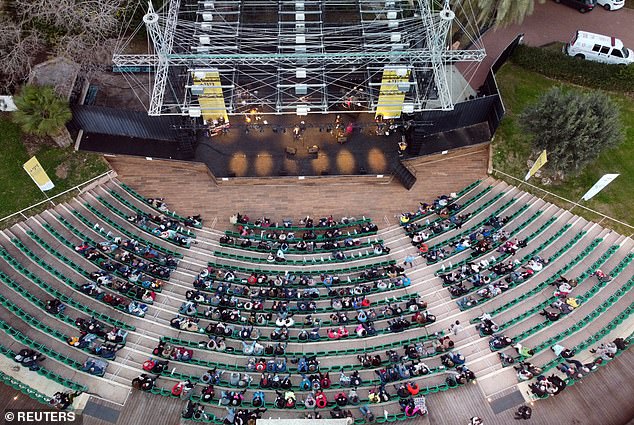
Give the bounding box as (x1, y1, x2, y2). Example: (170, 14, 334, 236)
(107, 145, 489, 225)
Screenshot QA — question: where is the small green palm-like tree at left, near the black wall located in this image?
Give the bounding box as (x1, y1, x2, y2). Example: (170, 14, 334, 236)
(13, 85, 72, 137)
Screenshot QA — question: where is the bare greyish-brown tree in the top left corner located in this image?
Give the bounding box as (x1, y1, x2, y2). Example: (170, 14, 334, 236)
(0, 0, 131, 88)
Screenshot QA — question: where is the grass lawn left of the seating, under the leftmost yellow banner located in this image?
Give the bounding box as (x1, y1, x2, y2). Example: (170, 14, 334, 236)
(0, 116, 108, 227)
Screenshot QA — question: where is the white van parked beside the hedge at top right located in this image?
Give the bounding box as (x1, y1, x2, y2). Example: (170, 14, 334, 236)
(564, 31, 634, 65)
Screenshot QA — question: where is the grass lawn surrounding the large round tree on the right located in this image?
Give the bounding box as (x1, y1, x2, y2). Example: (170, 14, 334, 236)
(493, 63, 634, 235)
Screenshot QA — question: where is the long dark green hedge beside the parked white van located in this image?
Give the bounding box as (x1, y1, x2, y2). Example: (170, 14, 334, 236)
(511, 45, 634, 93)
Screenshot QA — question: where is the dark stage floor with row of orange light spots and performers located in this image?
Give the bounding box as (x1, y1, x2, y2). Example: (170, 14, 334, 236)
(195, 114, 401, 177)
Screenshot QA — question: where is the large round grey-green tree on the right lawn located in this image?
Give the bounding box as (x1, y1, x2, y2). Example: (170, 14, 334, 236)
(520, 87, 623, 174)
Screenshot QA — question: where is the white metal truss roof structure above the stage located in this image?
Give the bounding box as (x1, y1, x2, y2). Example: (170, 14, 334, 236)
(113, 0, 485, 122)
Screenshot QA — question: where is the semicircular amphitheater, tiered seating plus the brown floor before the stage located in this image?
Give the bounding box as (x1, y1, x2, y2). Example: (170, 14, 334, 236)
(0, 152, 634, 425)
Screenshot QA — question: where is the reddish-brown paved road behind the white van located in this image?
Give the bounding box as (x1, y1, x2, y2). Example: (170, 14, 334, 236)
(459, 0, 634, 88)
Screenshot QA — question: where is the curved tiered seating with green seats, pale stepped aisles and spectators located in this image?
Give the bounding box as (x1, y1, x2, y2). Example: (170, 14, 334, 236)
(0, 176, 634, 424)
